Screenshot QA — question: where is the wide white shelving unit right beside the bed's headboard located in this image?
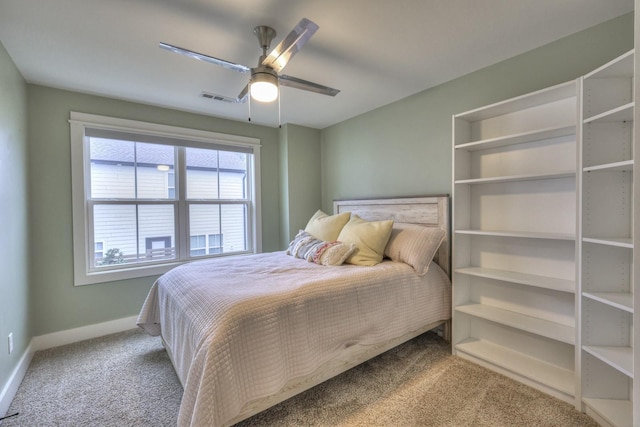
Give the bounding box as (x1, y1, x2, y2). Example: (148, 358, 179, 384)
(452, 81, 580, 407)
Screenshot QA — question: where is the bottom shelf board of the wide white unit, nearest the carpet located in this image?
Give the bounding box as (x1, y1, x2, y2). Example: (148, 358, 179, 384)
(455, 338, 575, 396)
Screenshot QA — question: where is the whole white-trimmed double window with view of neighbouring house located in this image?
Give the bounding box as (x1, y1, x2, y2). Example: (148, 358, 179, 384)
(70, 112, 260, 285)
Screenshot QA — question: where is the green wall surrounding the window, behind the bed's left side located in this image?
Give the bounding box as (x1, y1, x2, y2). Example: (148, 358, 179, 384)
(28, 85, 282, 336)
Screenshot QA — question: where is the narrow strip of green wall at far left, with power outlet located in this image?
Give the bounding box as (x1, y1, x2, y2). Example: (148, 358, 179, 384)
(0, 43, 31, 394)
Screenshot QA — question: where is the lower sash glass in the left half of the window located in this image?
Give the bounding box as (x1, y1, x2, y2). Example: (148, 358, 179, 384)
(93, 204, 175, 267)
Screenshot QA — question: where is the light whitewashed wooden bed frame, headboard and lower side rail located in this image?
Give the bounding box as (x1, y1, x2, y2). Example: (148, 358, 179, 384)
(229, 195, 451, 425)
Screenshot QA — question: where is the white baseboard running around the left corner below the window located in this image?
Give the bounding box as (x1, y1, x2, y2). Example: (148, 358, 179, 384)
(0, 316, 138, 417)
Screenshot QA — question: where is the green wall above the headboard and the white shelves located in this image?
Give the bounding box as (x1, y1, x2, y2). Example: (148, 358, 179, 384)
(321, 13, 633, 210)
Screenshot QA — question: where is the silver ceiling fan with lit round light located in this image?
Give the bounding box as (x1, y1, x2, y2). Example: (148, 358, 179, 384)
(160, 18, 340, 103)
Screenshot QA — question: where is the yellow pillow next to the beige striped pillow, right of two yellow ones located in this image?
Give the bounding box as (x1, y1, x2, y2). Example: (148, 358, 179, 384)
(338, 214, 393, 265)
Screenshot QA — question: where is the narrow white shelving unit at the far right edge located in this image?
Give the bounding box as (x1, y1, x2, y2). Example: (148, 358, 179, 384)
(578, 51, 640, 426)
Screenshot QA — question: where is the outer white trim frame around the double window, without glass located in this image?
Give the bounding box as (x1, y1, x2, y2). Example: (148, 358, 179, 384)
(69, 111, 262, 286)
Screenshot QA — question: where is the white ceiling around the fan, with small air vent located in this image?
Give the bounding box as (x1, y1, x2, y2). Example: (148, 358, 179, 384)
(0, 0, 634, 129)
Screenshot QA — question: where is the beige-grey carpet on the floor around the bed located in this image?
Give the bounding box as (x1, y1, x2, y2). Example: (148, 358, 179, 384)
(0, 330, 596, 427)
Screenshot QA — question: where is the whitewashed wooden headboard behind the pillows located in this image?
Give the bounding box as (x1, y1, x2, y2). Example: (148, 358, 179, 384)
(333, 195, 451, 277)
